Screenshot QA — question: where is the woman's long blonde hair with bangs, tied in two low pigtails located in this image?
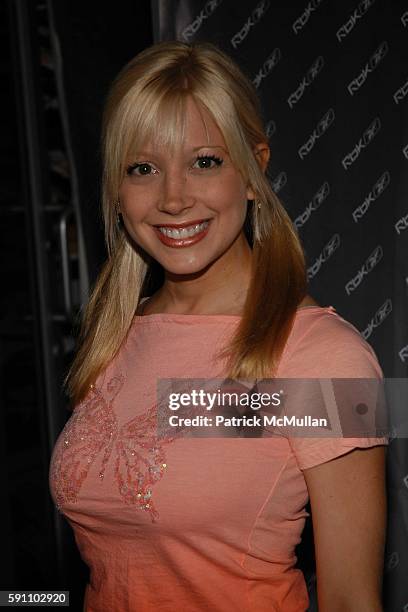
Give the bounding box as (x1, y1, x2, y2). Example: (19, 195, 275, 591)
(66, 41, 306, 402)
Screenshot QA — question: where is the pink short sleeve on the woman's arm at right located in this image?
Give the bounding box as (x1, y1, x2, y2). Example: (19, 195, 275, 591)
(278, 310, 389, 470)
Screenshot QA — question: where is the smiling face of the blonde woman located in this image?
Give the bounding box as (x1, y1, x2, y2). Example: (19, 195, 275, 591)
(119, 98, 254, 275)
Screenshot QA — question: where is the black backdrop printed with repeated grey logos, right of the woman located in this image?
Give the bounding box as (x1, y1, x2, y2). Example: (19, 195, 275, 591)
(152, 0, 408, 612)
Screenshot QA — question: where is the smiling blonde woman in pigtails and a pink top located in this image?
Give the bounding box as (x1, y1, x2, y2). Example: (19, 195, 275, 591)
(50, 42, 387, 612)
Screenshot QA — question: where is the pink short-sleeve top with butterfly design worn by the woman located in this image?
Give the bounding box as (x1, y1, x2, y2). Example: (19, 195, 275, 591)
(50, 306, 387, 612)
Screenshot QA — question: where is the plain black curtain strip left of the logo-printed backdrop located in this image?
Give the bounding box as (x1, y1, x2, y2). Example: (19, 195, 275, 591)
(48, 0, 153, 284)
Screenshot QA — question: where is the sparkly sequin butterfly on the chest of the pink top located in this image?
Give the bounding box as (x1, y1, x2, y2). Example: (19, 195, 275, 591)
(50, 374, 174, 522)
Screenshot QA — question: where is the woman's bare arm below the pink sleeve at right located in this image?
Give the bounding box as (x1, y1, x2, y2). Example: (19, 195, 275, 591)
(303, 446, 386, 612)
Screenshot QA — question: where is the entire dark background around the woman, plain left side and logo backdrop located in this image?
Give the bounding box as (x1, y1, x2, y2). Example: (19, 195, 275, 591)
(0, 0, 408, 612)
